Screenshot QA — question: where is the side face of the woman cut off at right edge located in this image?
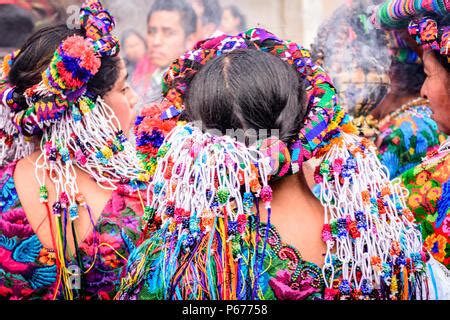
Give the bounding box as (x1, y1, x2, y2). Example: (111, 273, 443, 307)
(421, 51, 450, 134)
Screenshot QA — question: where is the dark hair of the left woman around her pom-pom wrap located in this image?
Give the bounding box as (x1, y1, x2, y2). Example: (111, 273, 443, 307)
(8, 25, 120, 99)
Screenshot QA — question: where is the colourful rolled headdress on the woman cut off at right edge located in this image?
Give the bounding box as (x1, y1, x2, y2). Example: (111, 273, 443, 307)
(372, 0, 450, 63)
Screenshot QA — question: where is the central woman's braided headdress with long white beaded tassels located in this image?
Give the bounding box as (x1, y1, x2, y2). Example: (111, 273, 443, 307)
(119, 29, 426, 300)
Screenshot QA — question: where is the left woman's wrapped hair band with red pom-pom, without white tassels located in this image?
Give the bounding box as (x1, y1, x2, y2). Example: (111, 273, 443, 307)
(14, 0, 120, 136)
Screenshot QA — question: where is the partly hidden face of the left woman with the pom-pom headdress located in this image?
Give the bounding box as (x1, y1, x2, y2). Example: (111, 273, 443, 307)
(102, 59, 138, 135)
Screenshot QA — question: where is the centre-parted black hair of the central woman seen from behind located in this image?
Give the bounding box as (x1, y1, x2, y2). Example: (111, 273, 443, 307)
(186, 49, 307, 143)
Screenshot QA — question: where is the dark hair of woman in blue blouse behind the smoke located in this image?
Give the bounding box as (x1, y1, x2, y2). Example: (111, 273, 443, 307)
(389, 58, 427, 95)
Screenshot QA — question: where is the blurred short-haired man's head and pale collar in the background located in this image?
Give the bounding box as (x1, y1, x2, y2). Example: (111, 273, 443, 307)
(142, 0, 197, 104)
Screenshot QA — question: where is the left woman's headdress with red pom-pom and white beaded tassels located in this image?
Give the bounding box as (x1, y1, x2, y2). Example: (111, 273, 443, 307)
(0, 0, 146, 298)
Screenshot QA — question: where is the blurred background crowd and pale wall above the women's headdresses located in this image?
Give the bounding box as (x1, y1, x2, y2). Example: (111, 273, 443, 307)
(0, 0, 366, 106)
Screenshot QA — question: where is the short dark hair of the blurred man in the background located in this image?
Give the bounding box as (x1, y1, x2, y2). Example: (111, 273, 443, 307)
(147, 0, 197, 37)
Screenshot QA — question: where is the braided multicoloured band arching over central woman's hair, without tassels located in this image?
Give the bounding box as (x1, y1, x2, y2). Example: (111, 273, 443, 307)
(136, 28, 353, 180)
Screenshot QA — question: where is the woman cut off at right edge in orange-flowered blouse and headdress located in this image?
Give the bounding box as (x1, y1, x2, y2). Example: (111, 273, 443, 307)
(374, 0, 450, 272)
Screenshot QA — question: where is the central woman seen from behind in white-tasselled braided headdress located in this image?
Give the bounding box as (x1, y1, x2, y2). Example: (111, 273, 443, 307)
(118, 29, 449, 300)
